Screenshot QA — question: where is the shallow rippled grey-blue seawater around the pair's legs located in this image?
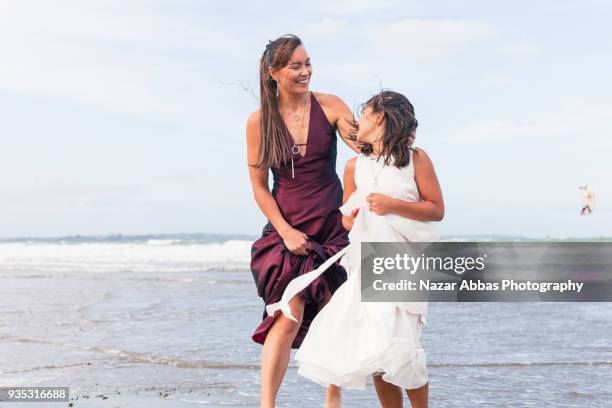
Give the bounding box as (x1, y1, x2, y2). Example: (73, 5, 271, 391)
(0, 241, 612, 408)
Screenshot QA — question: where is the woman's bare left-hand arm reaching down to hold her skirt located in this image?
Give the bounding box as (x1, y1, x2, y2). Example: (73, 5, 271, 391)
(246, 111, 308, 255)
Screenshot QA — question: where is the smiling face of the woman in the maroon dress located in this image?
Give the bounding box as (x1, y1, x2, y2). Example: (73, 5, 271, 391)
(270, 45, 312, 94)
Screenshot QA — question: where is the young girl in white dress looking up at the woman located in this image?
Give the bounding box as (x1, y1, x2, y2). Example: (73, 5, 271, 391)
(267, 91, 444, 408)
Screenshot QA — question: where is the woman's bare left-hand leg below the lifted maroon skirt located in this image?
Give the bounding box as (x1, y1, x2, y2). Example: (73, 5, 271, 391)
(260, 296, 304, 408)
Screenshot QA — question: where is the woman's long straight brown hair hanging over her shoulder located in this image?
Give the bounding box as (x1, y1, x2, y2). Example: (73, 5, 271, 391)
(256, 34, 302, 167)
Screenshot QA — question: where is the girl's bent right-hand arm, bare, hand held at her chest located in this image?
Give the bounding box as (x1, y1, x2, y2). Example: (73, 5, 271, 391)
(367, 149, 444, 221)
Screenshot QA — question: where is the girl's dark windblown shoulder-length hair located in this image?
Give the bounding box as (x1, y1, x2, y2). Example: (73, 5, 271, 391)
(361, 90, 419, 167)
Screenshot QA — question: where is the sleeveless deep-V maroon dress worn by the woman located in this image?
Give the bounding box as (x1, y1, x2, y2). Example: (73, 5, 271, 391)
(251, 93, 349, 348)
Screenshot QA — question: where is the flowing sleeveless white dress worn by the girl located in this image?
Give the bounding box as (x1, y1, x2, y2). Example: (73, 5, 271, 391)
(267, 152, 438, 389)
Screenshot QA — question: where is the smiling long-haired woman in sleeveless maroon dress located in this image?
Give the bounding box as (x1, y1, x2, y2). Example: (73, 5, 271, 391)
(247, 35, 358, 408)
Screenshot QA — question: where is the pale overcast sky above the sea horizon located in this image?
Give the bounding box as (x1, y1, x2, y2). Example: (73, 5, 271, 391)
(0, 0, 612, 237)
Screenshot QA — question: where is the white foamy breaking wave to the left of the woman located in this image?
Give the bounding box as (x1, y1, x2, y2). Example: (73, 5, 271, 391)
(0, 240, 252, 277)
